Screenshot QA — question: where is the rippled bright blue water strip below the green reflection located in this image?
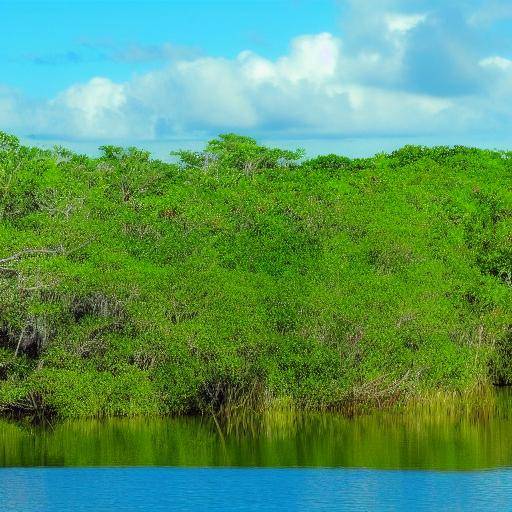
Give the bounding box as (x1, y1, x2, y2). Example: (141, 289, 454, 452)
(0, 468, 512, 512)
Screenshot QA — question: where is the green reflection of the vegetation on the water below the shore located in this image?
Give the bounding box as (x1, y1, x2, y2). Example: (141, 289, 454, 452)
(0, 392, 512, 470)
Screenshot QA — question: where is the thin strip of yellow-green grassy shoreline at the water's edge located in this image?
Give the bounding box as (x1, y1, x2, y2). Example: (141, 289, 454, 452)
(0, 385, 512, 430)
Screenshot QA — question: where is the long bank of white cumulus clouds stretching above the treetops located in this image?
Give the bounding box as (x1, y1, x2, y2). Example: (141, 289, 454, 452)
(0, 4, 512, 144)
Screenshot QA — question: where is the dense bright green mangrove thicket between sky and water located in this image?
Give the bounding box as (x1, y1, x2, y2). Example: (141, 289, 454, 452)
(0, 134, 512, 417)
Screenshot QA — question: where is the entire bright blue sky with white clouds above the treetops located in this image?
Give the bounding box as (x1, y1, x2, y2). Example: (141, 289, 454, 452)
(0, 0, 512, 156)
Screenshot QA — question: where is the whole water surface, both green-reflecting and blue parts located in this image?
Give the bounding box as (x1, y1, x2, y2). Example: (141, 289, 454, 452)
(0, 394, 512, 512)
